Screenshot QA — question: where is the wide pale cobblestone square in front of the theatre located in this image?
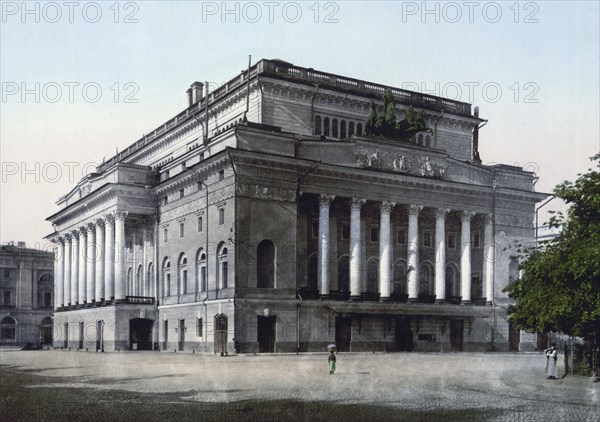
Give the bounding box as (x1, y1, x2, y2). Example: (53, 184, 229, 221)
(0, 351, 600, 422)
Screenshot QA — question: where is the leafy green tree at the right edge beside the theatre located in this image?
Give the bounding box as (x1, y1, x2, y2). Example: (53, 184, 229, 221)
(505, 154, 600, 344)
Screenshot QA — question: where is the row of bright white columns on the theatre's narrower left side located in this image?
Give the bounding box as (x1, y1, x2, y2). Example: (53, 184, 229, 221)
(54, 212, 127, 309)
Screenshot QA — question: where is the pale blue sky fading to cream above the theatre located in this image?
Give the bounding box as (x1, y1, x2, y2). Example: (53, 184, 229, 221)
(0, 1, 600, 248)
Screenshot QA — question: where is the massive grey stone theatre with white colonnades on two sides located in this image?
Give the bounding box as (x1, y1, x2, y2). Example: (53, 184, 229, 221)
(48, 60, 547, 353)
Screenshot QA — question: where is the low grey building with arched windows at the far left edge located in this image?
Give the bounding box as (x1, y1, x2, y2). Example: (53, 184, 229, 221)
(0, 242, 54, 347)
